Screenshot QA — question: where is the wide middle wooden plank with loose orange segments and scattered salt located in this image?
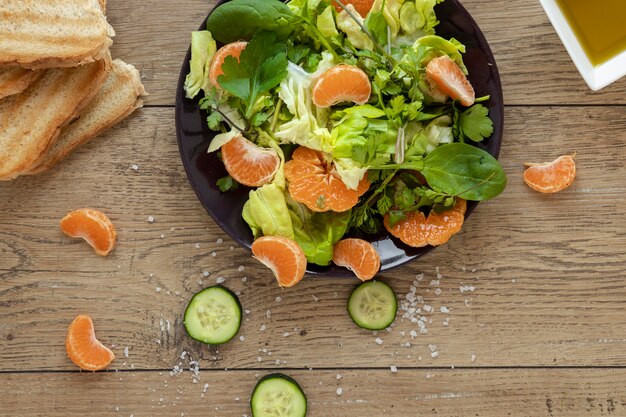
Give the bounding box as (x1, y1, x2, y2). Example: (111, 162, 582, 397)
(0, 107, 626, 370)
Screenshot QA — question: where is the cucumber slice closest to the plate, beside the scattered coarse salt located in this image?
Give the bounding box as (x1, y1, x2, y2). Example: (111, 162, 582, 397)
(348, 281, 398, 330)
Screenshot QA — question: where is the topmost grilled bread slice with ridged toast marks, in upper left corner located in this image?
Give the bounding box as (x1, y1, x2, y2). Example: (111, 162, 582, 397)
(0, 0, 115, 69)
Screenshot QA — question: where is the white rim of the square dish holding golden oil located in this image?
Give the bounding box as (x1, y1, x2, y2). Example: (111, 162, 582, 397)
(540, 0, 626, 91)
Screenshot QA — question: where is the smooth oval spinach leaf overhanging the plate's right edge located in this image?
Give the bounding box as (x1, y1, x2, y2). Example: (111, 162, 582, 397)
(421, 143, 506, 201)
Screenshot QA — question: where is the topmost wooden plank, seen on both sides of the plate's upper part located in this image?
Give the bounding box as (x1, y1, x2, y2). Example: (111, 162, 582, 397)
(107, 0, 626, 105)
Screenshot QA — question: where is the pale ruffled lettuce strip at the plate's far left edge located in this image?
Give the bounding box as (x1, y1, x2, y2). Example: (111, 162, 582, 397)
(185, 30, 217, 98)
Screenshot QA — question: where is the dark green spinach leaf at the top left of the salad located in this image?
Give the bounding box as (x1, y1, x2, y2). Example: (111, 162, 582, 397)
(207, 0, 301, 43)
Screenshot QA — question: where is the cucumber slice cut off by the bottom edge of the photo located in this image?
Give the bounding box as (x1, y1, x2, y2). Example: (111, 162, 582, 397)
(250, 374, 307, 417)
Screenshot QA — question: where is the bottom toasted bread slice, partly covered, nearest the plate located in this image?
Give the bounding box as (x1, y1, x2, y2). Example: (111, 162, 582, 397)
(26, 59, 146, 174)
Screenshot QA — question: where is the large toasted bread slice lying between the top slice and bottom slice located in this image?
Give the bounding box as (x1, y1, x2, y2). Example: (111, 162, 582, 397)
(0, 59, 110, 180)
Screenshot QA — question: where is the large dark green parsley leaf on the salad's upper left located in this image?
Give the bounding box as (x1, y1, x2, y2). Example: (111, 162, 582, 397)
(218, 32, 288, 119)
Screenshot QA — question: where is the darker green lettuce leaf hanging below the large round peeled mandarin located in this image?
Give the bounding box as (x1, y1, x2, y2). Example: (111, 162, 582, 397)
(287, 197, 351, 266)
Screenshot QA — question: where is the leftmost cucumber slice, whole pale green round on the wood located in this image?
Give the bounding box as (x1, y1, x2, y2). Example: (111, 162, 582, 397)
(185, 285, 241, 345)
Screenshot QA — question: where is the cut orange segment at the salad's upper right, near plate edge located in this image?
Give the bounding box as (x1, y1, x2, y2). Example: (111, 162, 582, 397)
(426, 55, 476, 107)
